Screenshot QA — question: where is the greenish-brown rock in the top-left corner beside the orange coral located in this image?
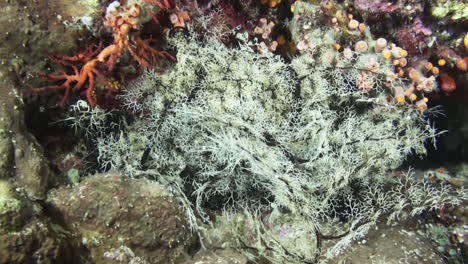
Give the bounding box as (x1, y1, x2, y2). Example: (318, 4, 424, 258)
(0, 0, 98, 86)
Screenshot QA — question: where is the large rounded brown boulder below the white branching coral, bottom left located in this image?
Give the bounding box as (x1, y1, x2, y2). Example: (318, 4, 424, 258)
(48, 173, 196, 263)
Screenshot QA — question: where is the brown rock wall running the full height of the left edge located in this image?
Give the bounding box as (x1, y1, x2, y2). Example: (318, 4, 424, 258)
(0, 0, 90, 256)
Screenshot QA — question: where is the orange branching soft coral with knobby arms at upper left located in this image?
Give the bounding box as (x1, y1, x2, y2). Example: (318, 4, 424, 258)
(24, 0, 175, 107)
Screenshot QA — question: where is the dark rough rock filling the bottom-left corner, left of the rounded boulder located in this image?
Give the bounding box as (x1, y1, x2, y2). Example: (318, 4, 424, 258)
(0, 180, 79, 264)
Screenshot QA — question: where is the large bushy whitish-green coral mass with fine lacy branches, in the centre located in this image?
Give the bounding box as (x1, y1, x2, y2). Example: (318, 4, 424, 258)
(97, 3, 466, 263)
